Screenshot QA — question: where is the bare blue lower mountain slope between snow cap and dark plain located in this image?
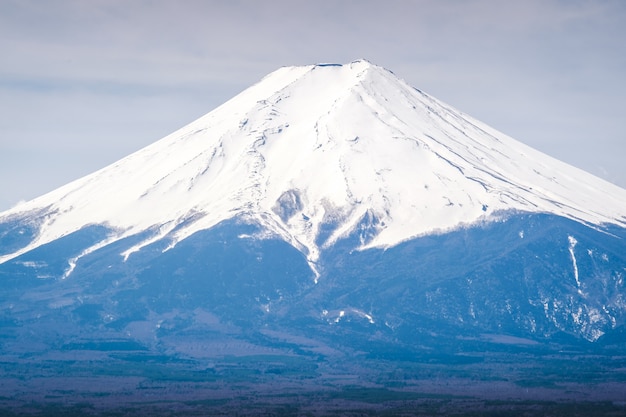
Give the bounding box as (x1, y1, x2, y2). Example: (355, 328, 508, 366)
(0, 208, 626, 349)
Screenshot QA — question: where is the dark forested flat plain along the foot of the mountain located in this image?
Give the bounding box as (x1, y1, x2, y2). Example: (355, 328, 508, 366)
(0, 353, 626, 417)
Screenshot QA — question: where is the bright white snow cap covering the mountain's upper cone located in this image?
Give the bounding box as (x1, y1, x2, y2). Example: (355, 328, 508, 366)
(0, 61, 626, 270)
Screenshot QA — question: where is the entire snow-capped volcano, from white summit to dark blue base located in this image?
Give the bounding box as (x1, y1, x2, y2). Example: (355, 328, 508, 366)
(0, 60, 626, 413)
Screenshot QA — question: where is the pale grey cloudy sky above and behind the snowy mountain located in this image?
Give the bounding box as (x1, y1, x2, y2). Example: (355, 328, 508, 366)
(0, 0, 626, 210)
